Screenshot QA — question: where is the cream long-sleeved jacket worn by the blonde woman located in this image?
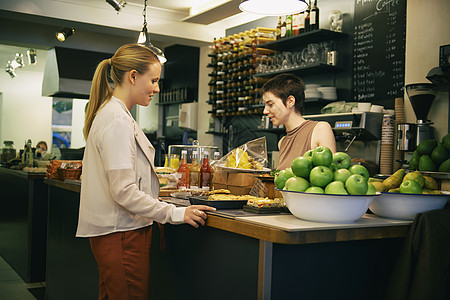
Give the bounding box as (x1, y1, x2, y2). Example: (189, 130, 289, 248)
(76, 97, 186, 237)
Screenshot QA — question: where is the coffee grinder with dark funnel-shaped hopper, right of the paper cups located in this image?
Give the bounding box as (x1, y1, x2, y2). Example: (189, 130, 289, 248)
(397, 83, 436, 151)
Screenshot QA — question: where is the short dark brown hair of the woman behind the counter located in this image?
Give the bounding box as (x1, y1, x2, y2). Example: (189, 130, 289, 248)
(261, 73, 305, 114)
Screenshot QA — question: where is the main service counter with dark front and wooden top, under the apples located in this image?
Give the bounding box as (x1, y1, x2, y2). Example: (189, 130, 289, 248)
(45, 179, 411, 300)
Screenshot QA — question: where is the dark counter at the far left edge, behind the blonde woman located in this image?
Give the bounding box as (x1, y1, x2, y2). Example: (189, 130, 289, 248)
(0, 167, 47, 282)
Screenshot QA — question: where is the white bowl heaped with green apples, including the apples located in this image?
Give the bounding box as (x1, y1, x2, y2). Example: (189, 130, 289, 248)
(274, 146, 379, 223)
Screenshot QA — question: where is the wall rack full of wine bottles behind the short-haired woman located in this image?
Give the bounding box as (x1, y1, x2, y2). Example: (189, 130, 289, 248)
(208, 27, 276, 117)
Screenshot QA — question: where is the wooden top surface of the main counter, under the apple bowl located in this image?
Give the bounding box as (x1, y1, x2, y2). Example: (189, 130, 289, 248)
(44, 182, 412, 244)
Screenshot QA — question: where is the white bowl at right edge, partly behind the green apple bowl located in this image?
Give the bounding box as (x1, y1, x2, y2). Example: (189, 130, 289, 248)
(370, 193, 449, 220)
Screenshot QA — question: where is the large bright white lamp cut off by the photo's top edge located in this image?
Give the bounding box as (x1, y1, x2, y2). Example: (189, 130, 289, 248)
(239, 0, 308, 16)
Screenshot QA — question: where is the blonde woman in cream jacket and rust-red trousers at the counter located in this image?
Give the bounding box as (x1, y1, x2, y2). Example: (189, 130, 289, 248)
(77, 44, 214, 300)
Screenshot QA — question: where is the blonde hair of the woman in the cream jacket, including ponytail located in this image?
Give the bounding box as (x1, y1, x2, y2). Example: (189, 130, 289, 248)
(83, 44, 159, 140)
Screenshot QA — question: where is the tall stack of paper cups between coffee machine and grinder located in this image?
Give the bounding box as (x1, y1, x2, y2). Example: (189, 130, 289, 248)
(380, 115, 394, 175)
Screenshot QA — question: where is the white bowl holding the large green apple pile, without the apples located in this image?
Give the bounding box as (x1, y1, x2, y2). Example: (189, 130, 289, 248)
(280, 190, 377, 223)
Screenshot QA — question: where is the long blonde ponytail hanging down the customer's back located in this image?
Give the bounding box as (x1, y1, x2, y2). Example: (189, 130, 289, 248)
(83, 59, 113, 141)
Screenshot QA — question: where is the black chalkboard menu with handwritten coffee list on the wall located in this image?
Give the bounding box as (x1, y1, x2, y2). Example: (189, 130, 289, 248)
(352, 0, 406, 103)
